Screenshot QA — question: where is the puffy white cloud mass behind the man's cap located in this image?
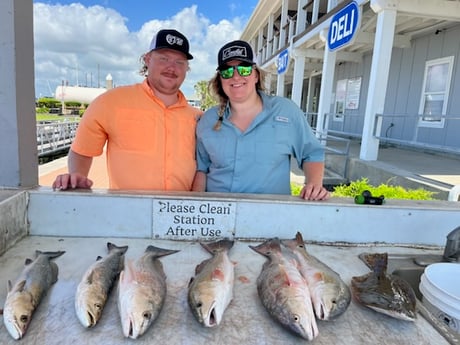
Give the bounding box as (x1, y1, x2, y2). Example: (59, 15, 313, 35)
(34, 3, 244, 97)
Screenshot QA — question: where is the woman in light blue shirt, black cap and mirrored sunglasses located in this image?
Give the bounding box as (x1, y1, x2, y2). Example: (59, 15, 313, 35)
(193, 40, 329, 200)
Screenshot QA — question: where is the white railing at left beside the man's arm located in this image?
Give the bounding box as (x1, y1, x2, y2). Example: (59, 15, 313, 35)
(37, 120, 79, 157)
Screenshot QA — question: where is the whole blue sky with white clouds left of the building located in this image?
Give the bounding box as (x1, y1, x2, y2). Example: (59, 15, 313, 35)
(33, 0, 258, 98)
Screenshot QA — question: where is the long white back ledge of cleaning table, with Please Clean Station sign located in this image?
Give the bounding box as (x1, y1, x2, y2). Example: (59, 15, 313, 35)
(28, 188, 460, 245)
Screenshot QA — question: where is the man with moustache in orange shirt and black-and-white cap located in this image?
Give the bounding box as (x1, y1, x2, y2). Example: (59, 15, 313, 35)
(53, 30, 201, 191)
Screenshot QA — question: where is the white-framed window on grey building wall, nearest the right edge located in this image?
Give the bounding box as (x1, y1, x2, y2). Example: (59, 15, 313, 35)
(419, 56, 454, 128)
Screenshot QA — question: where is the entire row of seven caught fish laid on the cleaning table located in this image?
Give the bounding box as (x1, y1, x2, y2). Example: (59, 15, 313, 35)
(3, 233, 415, 340)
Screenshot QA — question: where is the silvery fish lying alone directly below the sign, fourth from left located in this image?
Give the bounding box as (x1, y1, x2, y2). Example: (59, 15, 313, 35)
(188, 239, 234, 327)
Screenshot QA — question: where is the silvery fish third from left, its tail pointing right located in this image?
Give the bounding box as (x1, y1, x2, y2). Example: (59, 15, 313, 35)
(118, 246, 178, 339)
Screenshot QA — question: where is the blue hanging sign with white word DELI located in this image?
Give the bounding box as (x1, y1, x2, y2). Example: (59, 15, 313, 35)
(327, 1, 360, 50)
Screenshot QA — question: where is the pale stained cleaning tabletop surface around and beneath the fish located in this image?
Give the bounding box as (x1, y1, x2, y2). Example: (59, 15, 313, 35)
(0, 234, 447, 345)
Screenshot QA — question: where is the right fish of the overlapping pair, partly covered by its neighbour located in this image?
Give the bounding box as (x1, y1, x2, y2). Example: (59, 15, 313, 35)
(281, 232, 351, 320)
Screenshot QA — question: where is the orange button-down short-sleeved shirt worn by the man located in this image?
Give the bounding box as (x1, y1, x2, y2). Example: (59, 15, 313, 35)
(72, 80, 202, 191)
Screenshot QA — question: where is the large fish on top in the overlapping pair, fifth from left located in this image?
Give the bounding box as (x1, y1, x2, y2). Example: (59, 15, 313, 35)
(249, 238, 318, 340)
